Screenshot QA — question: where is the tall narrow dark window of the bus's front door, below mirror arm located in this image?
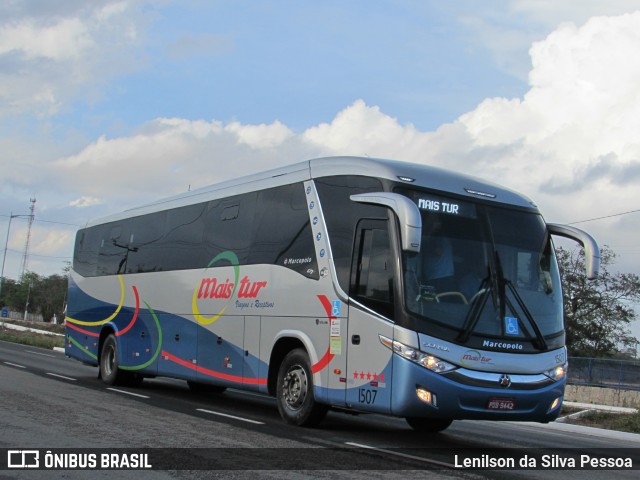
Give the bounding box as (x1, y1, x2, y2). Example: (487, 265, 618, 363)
(351, 220, 394, 319)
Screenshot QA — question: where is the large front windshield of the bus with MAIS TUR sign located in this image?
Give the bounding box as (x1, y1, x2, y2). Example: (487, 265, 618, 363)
(402, 191, 563, 351)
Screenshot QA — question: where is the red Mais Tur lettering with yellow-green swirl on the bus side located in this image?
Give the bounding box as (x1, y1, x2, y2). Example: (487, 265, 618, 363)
(191, 251, 267, 325)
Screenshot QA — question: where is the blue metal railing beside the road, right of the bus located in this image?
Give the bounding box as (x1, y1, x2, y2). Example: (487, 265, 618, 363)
(567, 357, 640, 390)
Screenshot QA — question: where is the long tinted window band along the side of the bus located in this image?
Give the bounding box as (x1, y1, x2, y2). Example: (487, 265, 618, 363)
(74, 184, 319, 278)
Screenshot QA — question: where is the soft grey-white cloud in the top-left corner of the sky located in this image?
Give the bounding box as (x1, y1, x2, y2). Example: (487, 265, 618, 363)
(0, 0, 145, 117)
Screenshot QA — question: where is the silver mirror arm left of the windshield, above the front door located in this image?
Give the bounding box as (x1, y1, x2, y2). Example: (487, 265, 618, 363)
(349, 192, 422, 253)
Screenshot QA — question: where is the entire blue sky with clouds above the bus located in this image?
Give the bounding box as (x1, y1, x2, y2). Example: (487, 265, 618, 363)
(0, 0, 640, 338)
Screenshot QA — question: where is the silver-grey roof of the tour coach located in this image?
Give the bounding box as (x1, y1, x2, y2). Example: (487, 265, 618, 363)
(87, 156, 536, 226)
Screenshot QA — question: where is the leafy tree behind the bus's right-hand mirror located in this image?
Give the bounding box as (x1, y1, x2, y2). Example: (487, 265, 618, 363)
(557, 245, 640, 357)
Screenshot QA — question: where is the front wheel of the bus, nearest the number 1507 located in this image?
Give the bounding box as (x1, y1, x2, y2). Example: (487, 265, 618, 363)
(276, 348, 328, 427)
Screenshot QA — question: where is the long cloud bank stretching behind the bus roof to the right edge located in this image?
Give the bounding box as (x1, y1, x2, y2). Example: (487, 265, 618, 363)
(12, 8, 640, 282)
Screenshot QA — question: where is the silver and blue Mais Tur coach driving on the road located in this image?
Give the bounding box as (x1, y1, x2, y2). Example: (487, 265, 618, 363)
(66, 157, 599, 432)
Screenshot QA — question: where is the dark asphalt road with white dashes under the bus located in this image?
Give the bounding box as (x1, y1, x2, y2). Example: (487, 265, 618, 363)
(0, 342, 640, 480)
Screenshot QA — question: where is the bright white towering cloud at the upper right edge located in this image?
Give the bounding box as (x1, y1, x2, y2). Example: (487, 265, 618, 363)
(458, 12, 640, 194)
